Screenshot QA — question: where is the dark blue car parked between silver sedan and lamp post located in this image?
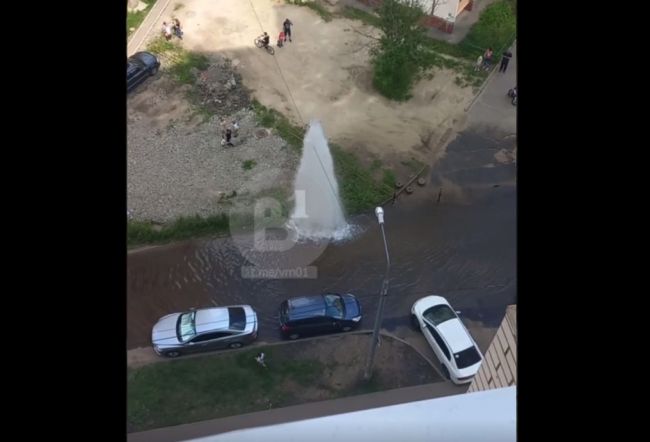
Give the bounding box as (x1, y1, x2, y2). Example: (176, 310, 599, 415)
(280, 293, 362, 339)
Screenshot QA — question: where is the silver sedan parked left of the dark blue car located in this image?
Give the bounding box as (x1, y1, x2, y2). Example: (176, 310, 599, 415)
(151, 305, 257, 358)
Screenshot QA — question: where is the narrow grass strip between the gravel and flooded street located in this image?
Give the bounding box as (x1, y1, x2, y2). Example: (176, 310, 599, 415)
(126, 215, 230, 246)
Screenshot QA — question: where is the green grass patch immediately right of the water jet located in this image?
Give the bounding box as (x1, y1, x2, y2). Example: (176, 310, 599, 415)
(330, 144, 395, 215)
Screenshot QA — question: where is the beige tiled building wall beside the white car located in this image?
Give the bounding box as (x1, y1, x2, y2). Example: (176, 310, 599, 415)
(467, 305, 517, 392)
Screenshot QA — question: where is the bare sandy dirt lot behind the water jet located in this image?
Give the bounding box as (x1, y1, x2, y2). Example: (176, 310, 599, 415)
(143, 0, 473, 163)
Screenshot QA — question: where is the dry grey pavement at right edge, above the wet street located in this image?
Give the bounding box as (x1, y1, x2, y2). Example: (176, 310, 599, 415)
(468, 41, 517, 134)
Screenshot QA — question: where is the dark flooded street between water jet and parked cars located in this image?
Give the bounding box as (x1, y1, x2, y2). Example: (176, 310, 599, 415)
(127, 131, 517, 351)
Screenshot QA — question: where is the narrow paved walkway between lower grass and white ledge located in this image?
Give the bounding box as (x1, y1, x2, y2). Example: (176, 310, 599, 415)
(127, 382, 469, 442)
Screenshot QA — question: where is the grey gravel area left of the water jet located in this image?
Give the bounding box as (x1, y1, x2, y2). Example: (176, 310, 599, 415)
(127, 55, 300, 223)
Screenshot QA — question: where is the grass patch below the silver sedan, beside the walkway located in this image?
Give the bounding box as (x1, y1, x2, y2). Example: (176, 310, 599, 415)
(127, 347, 323, 431)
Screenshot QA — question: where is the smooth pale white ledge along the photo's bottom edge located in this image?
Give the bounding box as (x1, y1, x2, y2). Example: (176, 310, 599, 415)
(188, 387, 517, 442)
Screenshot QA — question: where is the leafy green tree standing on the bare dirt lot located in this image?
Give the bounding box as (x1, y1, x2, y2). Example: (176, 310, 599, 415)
(372, 0, 426, 100)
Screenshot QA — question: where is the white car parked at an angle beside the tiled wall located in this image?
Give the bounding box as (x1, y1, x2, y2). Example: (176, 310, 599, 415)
(411, 296, 483, 384)
